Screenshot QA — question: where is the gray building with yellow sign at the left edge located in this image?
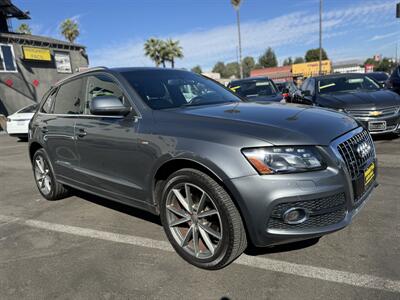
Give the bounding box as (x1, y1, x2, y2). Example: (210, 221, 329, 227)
(0, 0, 89, 116)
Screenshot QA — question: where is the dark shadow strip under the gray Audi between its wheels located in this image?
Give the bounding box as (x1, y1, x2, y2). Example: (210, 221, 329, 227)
(71, 189, 161, 226)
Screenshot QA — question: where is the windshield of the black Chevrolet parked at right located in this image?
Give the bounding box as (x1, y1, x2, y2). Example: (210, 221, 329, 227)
(318, 75, 380, 94)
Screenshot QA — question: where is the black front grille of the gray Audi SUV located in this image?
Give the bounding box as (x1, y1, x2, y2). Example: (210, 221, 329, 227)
(337, 130, 375, 180)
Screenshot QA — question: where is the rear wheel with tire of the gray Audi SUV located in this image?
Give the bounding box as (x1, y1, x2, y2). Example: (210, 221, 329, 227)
(32, 148, 69, 200)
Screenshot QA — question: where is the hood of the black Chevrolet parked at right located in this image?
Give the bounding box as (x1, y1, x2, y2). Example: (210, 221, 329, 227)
(318, 90, 400, 110)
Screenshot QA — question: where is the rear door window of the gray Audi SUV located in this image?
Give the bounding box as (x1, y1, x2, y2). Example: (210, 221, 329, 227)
(54, 79, 84, 114)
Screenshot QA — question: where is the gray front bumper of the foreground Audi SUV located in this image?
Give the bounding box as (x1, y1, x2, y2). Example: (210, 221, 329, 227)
(225, 128, 377, 247)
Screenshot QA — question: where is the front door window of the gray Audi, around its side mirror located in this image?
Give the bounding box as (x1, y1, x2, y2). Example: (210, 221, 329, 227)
(83, 74, 127, 115)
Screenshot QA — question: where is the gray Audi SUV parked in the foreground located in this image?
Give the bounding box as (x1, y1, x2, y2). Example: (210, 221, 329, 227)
(29, 68, 377, 269)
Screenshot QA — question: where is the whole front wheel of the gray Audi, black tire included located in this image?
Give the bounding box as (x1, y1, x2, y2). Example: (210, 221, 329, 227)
(160, 169, 247, 270)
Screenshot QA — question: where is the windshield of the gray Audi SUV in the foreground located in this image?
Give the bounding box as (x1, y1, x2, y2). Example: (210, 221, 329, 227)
(121, 70, 241, 109)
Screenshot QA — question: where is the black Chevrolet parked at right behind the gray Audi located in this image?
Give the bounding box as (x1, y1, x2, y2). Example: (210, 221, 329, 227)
(296, 74, 400, 134)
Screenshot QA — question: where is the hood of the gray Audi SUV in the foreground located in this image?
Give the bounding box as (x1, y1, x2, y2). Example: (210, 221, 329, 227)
(159, 102, 359, 145)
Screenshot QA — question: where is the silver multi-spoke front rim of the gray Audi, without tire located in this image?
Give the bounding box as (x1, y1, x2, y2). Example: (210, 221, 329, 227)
(166, 183, 223, 259)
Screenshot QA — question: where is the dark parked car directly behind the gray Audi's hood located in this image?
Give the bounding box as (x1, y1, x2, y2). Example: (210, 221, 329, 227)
(228, 77, 283, 102)
